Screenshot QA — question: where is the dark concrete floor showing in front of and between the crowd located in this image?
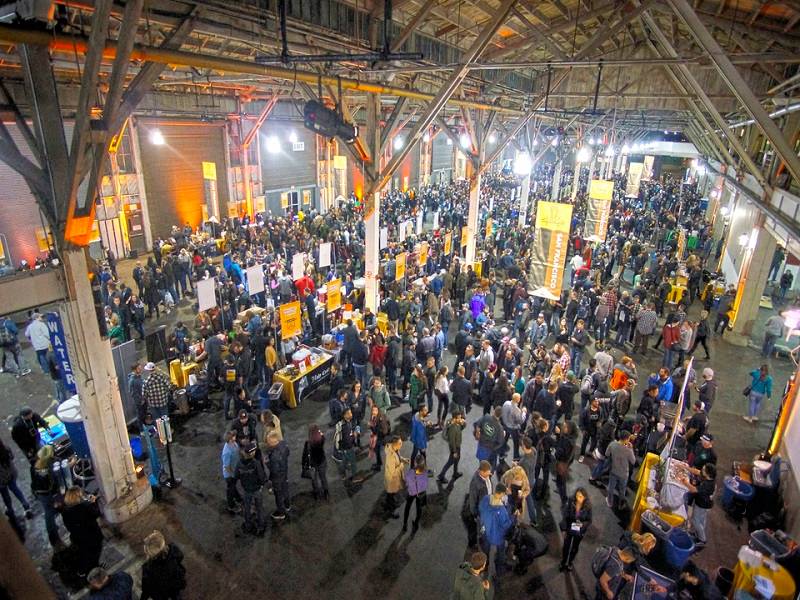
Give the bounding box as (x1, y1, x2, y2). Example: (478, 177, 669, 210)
(0, 258, 794, 600)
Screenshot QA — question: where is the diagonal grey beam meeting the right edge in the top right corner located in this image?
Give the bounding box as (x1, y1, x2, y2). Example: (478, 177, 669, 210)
(668, 0, 800, 182)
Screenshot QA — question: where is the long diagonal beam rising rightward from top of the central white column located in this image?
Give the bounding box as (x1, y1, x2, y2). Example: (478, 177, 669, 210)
(368, 0, 517, 194)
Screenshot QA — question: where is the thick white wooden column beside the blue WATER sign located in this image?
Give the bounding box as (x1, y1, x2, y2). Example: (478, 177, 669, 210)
(62, 249, 152, 523)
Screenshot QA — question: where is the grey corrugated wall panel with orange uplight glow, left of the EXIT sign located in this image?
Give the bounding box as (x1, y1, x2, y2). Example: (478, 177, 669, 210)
(137, 119, 229, 238)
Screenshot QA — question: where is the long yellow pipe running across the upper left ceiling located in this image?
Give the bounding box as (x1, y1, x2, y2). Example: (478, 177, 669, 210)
(0, 25, 524, 115)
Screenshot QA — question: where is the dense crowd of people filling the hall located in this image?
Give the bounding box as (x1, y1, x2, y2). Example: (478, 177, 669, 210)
(0, 162, 788, 599)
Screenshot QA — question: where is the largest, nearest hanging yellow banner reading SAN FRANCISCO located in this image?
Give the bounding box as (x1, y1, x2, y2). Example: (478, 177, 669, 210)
(530, 201, 572, 300)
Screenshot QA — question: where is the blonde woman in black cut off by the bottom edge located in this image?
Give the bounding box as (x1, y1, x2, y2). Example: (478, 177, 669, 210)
(141, 531, 186, 600)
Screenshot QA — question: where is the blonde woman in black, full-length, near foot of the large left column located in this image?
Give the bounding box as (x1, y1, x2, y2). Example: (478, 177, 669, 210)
(61, 485, 104, 577)
